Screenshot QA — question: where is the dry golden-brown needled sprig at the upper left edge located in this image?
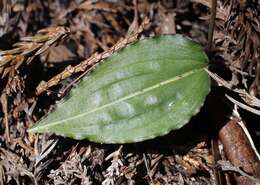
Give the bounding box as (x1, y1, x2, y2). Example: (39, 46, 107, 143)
(0, 27, 70, 78)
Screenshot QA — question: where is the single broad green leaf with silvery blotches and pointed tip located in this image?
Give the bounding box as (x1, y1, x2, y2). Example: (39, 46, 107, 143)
(29, 35, 210, 143)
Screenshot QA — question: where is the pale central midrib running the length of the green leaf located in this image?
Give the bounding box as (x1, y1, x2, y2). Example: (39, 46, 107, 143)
(29, 68, 203, 132)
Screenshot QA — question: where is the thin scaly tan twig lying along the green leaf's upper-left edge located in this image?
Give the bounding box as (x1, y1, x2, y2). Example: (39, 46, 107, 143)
(36, 18, 149, 95)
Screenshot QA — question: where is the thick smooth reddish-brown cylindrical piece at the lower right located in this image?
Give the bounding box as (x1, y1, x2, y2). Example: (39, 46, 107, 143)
(219, 120, 260, 185)
